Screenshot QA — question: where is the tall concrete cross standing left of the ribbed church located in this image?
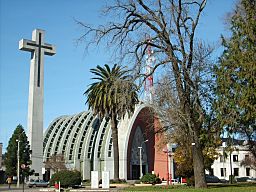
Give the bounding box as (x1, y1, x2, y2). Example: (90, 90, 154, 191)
(19, 29, 56, 178)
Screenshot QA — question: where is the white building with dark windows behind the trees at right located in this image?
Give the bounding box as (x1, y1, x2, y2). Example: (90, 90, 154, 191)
(210, 142, 256, 180)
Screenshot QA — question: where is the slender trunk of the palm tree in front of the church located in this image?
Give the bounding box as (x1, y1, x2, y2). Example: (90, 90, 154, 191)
(111, 115, 119, 180)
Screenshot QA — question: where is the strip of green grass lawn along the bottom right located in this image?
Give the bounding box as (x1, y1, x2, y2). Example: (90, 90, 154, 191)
(124, 183, 256, 192)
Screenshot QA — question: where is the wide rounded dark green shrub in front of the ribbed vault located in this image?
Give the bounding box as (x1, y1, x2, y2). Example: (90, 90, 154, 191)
(50, 170, 81, 188)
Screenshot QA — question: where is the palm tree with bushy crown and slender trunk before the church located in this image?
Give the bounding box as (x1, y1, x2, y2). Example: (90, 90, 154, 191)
(84, 64, 138, 180)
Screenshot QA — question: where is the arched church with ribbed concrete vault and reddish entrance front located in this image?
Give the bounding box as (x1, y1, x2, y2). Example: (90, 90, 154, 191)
(43, 104, 167, 180)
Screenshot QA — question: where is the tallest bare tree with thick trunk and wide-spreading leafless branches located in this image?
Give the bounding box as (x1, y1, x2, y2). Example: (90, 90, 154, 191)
(78, 0, 210, 187)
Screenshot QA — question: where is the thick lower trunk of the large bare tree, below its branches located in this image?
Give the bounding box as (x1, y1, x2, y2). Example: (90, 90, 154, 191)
(192, 131, 207, 188)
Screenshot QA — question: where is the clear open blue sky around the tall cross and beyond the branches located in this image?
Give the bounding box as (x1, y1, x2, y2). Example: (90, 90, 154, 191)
(0, 0, 236, 152)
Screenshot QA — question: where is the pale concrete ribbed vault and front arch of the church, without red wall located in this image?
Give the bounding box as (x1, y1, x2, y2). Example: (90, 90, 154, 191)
(44, 104, 159, 179)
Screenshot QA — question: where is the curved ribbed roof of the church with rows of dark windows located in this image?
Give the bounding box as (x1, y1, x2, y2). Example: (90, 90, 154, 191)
(43, 112, 112, 163)
